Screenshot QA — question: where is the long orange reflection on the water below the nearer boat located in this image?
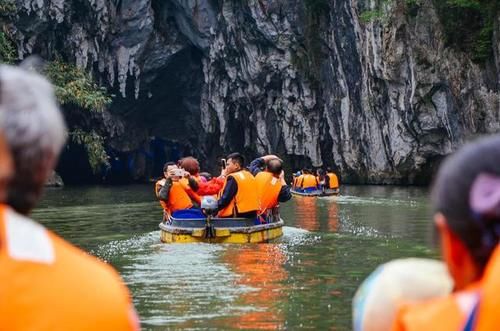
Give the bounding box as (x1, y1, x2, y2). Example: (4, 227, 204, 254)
(216, 244, 288, 330)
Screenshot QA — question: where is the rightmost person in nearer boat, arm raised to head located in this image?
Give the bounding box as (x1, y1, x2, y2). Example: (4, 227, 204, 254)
(248, 155, 292, 214)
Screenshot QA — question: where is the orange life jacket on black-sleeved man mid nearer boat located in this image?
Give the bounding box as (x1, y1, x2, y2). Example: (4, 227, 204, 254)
(219, 170, 259, 217)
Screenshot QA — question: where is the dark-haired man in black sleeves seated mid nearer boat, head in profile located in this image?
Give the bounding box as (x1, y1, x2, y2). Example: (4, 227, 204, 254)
(217, 153, 259, 218)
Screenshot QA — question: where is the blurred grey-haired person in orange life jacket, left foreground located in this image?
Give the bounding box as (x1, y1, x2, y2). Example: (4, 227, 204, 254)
(0, 65, 140, 331)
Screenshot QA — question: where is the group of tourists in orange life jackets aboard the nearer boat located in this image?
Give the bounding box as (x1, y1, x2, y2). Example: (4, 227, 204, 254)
(155, 153, 291, 223)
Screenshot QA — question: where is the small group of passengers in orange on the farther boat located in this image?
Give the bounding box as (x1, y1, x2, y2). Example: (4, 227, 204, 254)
(292, 168, 340, 192)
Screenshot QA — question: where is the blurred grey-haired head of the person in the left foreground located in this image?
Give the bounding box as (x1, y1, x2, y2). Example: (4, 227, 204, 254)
(0, 65, 67, 214)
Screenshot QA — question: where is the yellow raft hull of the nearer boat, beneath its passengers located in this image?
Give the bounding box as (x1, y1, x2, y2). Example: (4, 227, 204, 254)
(160, 214, 284, 244)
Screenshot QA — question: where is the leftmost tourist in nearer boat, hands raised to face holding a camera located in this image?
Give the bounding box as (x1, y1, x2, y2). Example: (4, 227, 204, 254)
(155, 162, 202, 216)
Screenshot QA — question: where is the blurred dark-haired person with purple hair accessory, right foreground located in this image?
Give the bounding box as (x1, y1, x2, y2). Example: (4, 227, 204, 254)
(392, 136, 500, 331)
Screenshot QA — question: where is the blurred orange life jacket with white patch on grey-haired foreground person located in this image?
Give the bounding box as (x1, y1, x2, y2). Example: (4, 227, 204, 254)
(0, 205, 139, 331)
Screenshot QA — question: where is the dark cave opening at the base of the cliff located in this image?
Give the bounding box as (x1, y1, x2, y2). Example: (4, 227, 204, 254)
(57, 47, 204, 184)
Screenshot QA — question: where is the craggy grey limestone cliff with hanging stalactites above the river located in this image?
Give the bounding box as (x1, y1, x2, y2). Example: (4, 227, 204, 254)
(4, 0, 500, 184)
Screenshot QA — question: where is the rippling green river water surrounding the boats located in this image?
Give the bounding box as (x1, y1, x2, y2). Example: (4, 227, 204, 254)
(33, 185, 437, 330)
